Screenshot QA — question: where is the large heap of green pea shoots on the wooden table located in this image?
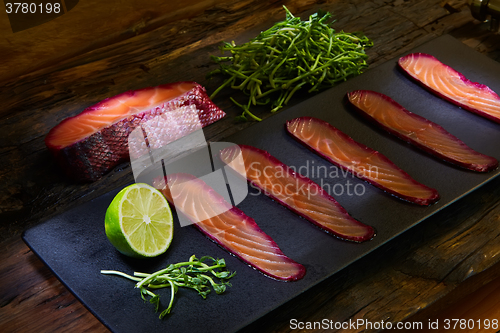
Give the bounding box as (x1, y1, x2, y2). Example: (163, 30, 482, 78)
(209, 6, 373, 121)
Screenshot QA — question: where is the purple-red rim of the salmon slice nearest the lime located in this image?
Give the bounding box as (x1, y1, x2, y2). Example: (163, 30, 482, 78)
(153, 177, 306, 282)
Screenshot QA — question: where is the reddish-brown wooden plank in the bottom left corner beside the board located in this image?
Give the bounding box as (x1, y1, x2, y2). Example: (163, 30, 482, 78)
(0, 238, 108, 332)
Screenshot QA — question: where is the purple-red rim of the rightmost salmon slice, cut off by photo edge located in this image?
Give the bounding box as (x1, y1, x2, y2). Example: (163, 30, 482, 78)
(398, 52, 500, 124)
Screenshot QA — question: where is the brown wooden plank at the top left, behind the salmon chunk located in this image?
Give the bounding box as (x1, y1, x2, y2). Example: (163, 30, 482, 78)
(0, 0, 240, 82)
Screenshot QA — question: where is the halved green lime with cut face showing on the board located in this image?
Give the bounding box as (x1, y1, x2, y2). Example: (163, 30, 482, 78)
(105, 183, 174, 258)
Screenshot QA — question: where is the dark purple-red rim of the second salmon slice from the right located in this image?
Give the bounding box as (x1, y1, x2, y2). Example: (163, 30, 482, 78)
(346, 90, 498, 172)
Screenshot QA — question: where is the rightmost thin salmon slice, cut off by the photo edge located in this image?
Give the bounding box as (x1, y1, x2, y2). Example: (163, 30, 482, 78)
(398, 53, 500, 123)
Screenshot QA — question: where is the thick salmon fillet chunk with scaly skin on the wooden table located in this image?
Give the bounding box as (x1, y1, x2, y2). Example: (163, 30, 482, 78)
(45, 81, 225, 181)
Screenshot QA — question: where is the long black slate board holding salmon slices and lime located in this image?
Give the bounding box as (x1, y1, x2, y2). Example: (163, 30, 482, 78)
(23, 36, 500, 333)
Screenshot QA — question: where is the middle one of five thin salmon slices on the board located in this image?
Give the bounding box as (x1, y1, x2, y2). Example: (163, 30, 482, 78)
(286, 117, 439, 206)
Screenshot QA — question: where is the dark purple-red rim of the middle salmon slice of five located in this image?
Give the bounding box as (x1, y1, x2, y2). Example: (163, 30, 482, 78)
(285, 117, 440, 206)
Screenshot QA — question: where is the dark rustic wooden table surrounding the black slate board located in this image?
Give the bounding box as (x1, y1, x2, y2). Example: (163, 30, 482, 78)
(0, 0, 500, 332)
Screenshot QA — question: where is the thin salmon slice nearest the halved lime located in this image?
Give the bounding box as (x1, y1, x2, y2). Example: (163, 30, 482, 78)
(153, 173, 306, 281)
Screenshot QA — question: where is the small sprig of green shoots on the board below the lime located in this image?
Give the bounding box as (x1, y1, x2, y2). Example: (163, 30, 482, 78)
(101, 255, 236, 319)
